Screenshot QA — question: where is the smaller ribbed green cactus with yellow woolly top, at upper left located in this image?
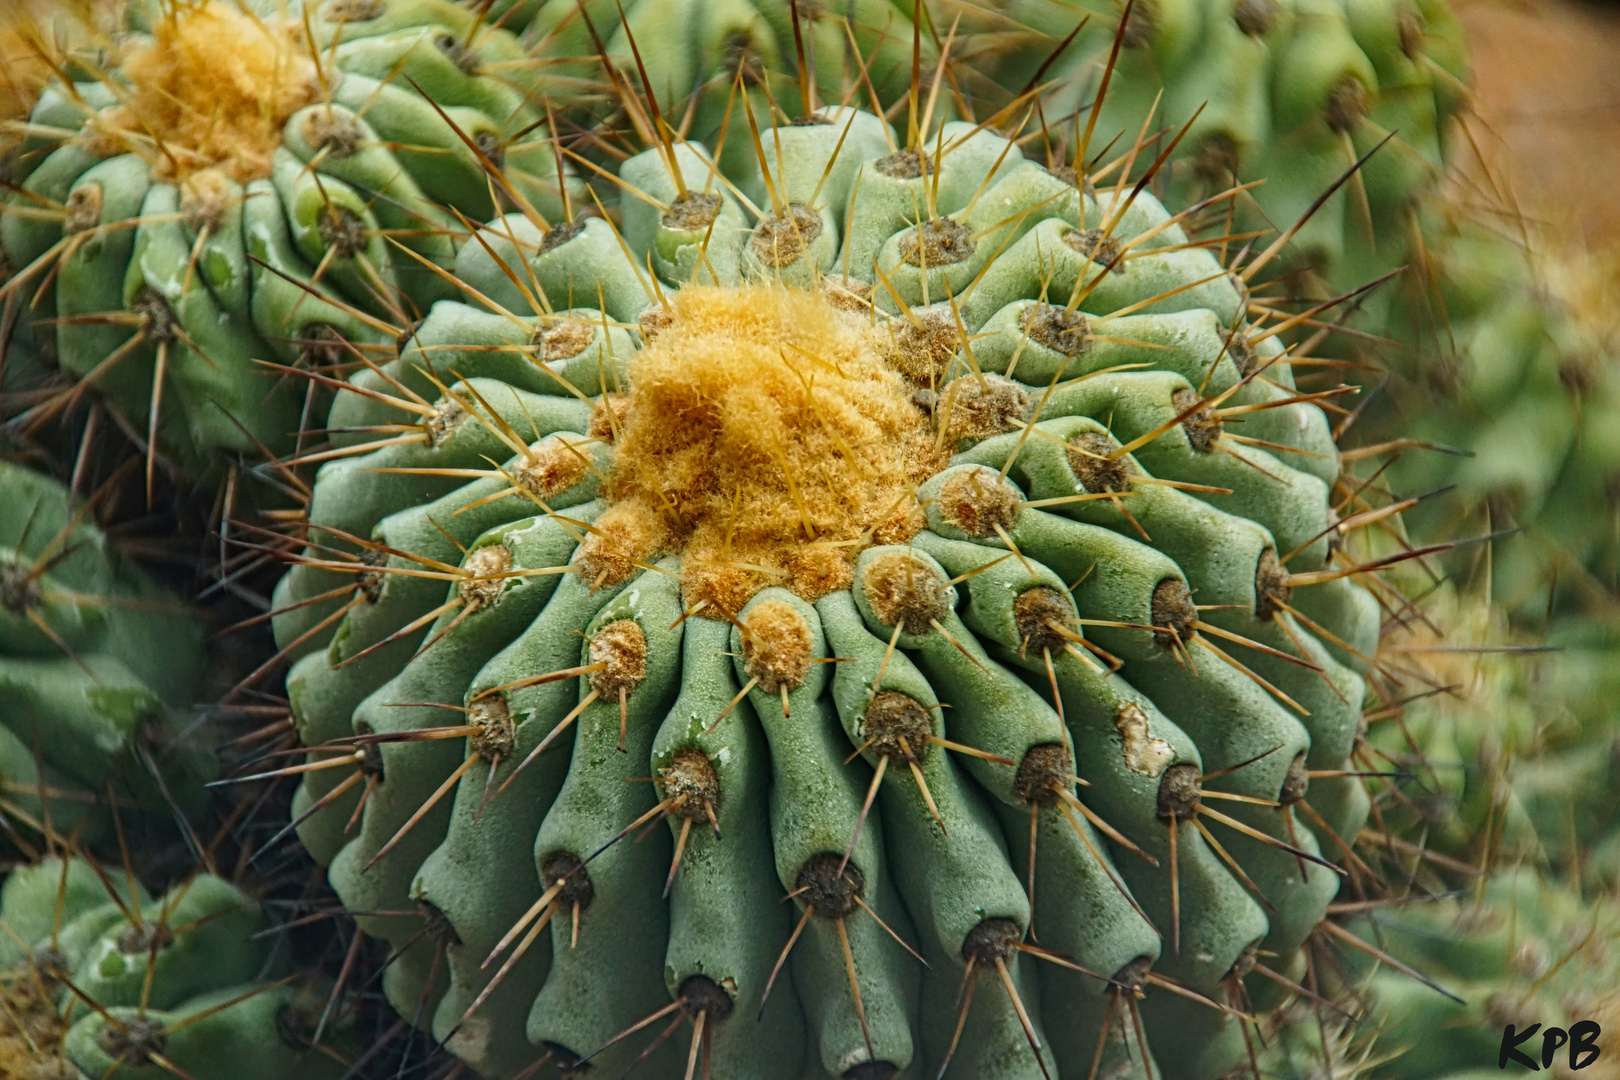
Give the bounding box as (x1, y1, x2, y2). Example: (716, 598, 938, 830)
(0, 0, 583, 484)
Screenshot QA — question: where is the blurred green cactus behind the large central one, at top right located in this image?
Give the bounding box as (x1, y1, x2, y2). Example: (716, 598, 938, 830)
(961, 0, 1468, 291)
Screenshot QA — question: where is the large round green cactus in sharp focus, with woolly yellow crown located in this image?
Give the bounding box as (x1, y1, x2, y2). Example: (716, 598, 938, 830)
(221, 14, 1477, 1080)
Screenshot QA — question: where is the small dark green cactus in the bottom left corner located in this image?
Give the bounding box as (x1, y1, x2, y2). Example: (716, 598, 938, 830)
(0, 855, 352, 1080)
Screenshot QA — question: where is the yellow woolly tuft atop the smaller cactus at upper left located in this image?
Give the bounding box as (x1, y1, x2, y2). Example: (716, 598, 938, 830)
(94, 0, 321, 181)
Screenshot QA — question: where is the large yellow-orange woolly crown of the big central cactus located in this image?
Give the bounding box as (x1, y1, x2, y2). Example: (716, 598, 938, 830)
(585, 285, 943, 614)
